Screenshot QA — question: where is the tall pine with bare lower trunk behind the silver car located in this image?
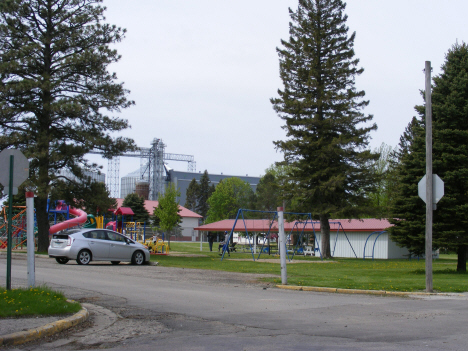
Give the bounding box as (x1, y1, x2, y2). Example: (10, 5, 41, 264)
(0, 0, 134, 251)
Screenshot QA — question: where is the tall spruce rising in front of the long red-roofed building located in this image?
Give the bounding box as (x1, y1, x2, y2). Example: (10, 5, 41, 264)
(271, 0, 377, 257)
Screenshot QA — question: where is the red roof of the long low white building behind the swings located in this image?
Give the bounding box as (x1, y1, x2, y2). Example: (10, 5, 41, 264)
(195, 218, 392, 232)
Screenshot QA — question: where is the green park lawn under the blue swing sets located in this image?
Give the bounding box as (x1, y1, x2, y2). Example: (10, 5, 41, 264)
(152, 242, 468, 292)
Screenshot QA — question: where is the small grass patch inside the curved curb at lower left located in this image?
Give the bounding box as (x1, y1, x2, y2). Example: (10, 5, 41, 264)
(0, 287, 81, 318)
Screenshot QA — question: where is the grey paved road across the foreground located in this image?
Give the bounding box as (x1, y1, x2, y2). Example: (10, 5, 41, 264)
(0, 259, 468, 351)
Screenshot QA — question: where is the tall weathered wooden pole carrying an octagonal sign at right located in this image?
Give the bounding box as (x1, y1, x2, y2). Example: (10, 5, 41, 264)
(425, 61, 433, 292)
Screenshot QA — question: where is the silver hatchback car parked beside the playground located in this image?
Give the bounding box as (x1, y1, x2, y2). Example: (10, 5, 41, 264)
(48, 229, 150, 265)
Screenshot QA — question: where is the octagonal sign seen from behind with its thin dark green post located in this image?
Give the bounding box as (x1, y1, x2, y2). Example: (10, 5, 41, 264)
(0, 149, 29, 290)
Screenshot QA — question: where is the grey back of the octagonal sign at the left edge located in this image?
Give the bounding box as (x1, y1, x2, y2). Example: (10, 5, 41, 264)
(0, 149, 29, 189)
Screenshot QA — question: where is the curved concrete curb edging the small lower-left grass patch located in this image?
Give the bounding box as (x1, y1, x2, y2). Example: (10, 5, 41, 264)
(0, 307, 89, 347)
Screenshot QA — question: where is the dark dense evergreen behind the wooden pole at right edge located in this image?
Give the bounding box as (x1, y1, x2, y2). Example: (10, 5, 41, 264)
(392, 43, 468, 272)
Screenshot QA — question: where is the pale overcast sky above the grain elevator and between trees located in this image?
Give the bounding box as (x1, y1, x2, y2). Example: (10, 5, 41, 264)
(86, 0, 468, 180)
